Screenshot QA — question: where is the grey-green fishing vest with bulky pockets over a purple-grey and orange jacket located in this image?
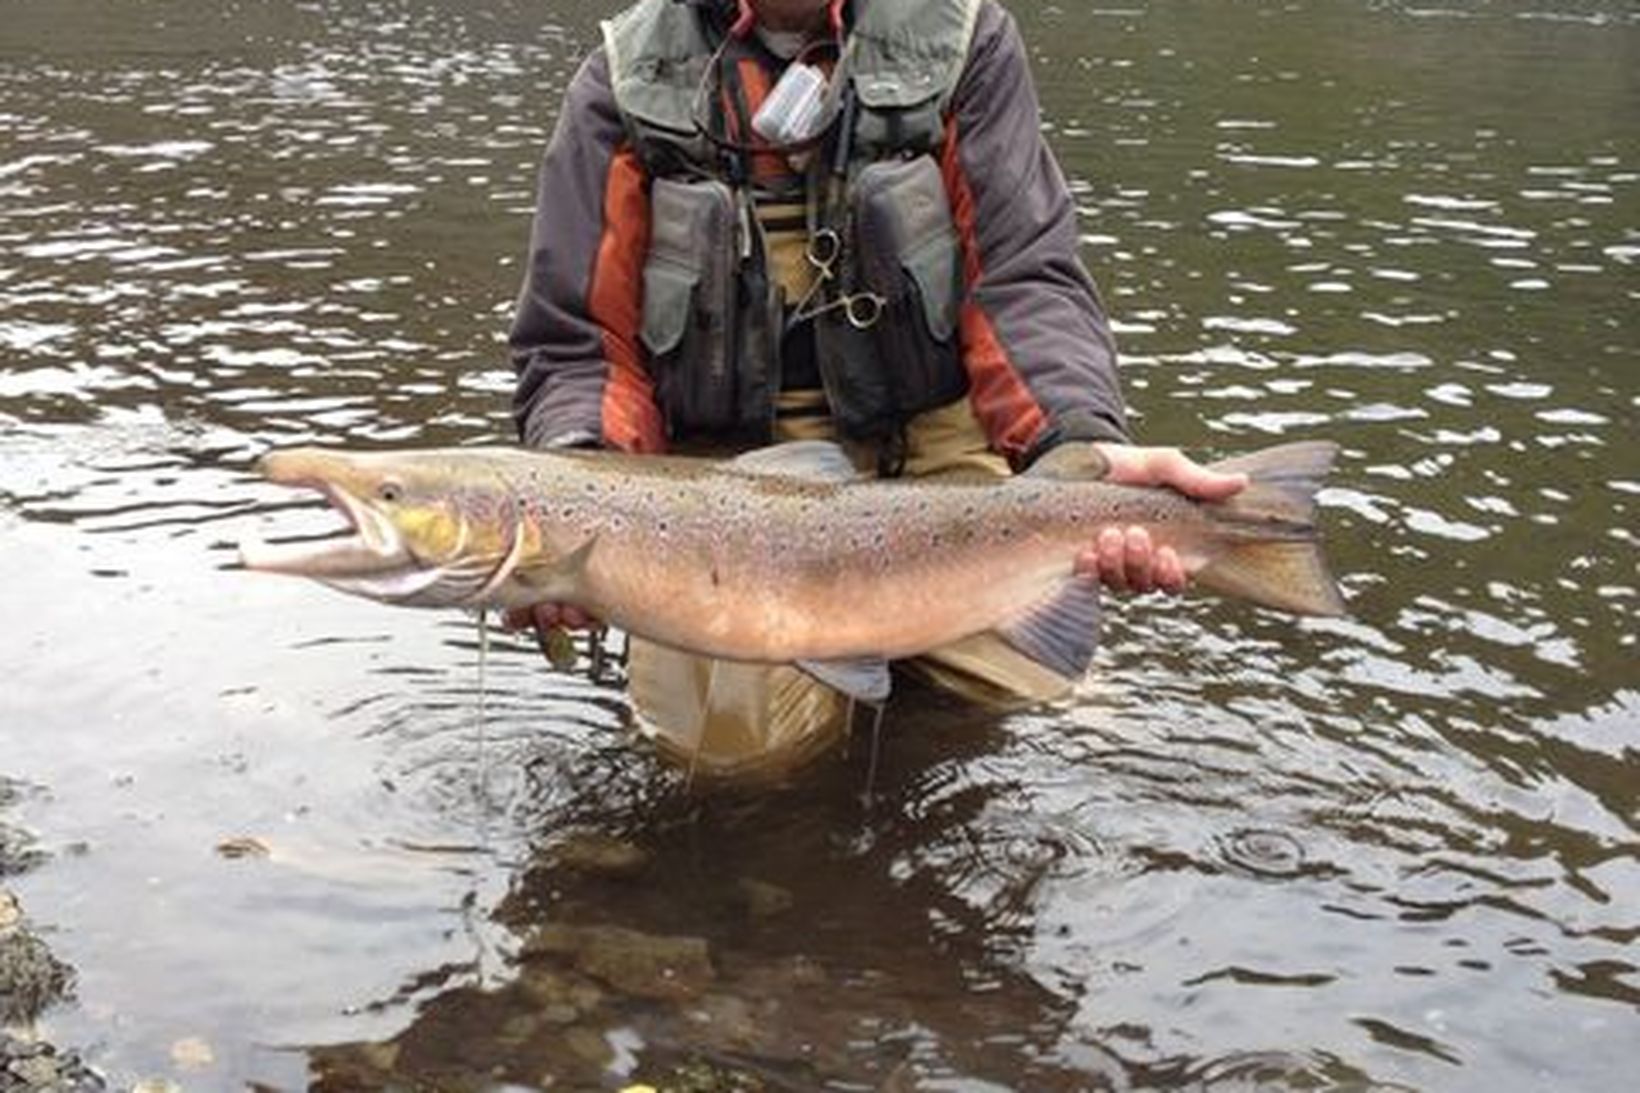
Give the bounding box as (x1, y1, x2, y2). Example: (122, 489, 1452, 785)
(604, 0, 981, 446)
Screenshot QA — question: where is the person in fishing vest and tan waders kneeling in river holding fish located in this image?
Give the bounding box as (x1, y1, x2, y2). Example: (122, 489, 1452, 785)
(508, 0, 1243, 775)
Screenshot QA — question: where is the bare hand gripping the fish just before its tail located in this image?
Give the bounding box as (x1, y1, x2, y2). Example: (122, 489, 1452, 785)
(1076, 443, 1246, 592)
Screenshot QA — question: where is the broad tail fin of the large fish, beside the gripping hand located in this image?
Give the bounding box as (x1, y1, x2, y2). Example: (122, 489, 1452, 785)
(1196, 440, 1345, 615)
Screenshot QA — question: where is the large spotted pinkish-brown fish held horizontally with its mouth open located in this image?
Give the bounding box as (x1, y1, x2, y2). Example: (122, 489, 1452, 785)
(241, 441, 1343, 663)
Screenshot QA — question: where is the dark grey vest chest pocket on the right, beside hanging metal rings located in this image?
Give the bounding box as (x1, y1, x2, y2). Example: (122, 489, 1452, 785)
(854, 156, 968, 417)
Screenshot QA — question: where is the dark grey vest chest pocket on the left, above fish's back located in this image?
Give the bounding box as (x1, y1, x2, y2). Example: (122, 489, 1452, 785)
(640, 179, 740, 433)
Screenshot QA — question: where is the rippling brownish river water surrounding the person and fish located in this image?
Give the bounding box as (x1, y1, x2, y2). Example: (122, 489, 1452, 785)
(0, 0, 1640, 1090)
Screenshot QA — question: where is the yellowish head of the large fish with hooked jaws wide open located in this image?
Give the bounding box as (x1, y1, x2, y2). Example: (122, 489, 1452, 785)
(239, 448, 522, 607)
